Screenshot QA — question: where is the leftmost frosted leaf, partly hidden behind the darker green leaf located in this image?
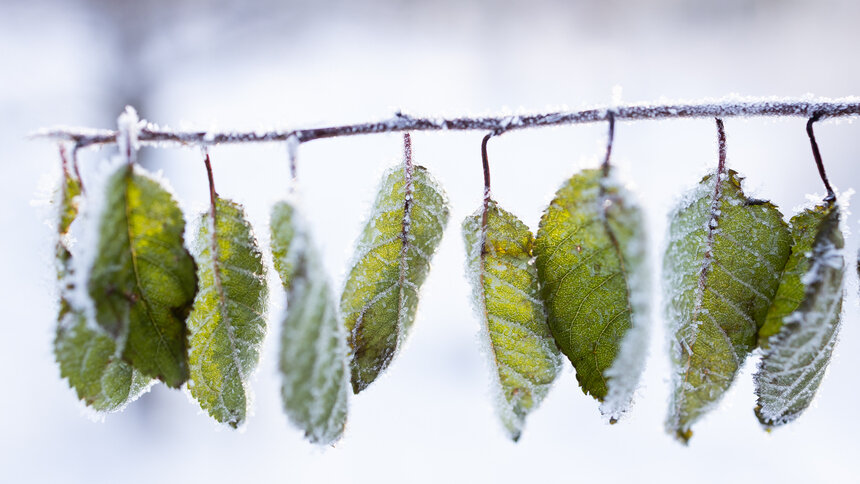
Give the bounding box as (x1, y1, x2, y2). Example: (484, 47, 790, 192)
(54, 170, 150, 412)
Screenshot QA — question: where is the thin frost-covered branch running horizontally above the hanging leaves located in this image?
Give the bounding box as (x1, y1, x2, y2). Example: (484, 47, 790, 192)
(32, 97, 860, 147)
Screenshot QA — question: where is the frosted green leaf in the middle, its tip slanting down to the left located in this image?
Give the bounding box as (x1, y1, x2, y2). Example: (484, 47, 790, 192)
(340, 166, 449, 393)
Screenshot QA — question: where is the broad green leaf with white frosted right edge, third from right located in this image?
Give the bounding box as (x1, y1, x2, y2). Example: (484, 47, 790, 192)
(534, 169, 649, 422)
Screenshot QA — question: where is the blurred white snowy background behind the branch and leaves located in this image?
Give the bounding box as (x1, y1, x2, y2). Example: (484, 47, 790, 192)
(0, 0, 860, 482)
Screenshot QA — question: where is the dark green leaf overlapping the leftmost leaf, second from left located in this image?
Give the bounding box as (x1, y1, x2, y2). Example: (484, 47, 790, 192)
(87, 165, 197, 388)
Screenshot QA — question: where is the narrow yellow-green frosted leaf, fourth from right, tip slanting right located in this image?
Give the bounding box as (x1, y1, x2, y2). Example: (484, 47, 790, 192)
(463, 200, 561, 441)
